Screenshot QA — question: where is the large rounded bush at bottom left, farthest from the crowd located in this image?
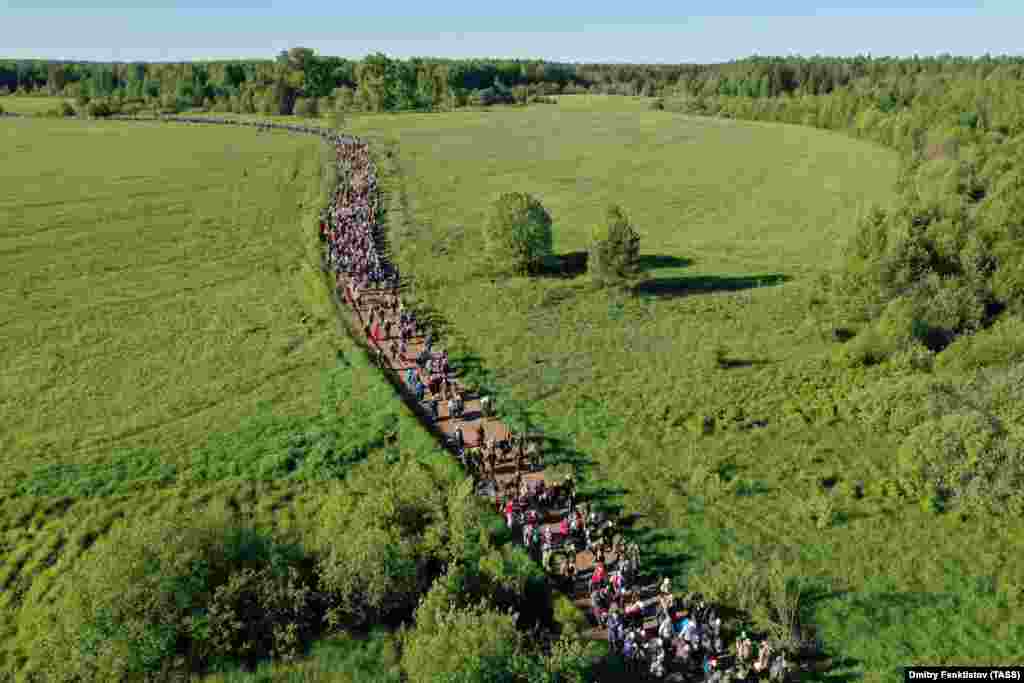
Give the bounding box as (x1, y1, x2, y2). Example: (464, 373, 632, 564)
(23, 511, 314, 681)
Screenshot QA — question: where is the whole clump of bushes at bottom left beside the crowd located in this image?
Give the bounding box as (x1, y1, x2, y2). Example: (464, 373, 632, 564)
(20, 446, 590, 681)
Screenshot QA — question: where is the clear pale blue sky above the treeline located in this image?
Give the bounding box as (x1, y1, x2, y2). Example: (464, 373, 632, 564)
(0, 0, 1024, 63)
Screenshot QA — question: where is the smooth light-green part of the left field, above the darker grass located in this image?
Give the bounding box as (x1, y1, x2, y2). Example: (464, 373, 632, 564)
(0, 120, 343, 482)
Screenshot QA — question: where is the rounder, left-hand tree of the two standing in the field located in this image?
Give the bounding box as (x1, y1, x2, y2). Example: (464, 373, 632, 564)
(483, 193, 552, 273)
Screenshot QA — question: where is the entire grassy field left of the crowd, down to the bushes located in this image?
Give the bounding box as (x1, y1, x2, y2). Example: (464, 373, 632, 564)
(0, 120, 450, 680)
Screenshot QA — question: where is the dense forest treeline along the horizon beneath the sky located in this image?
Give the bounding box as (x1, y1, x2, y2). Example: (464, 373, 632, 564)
(9, 47, 1024, 114)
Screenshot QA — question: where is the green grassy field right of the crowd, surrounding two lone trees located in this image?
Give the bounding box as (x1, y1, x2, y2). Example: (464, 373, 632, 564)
(339, 98, 1024, 680)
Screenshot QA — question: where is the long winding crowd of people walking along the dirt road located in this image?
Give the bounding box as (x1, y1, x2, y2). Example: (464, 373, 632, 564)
(321, 125, 790, 683)
